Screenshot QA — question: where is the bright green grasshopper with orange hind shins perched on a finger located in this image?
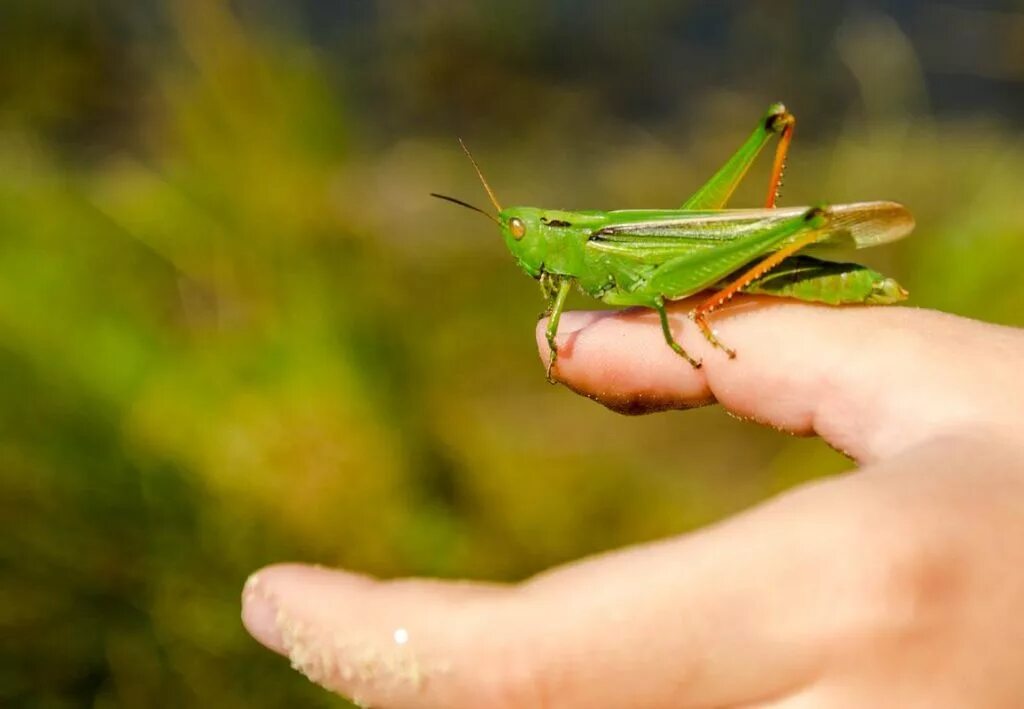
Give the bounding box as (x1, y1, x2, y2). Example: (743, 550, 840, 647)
(432, 103, 913, 379)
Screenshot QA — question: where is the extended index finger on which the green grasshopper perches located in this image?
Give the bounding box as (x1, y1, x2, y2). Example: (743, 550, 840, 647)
(538, 296, 1024, 462)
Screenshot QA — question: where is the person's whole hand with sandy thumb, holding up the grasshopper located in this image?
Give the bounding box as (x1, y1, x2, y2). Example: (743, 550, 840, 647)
(243, 296, 1024, 709)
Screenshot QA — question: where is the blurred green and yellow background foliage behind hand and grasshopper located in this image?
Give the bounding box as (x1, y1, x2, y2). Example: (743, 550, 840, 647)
(0, 0, 1024, 707)
